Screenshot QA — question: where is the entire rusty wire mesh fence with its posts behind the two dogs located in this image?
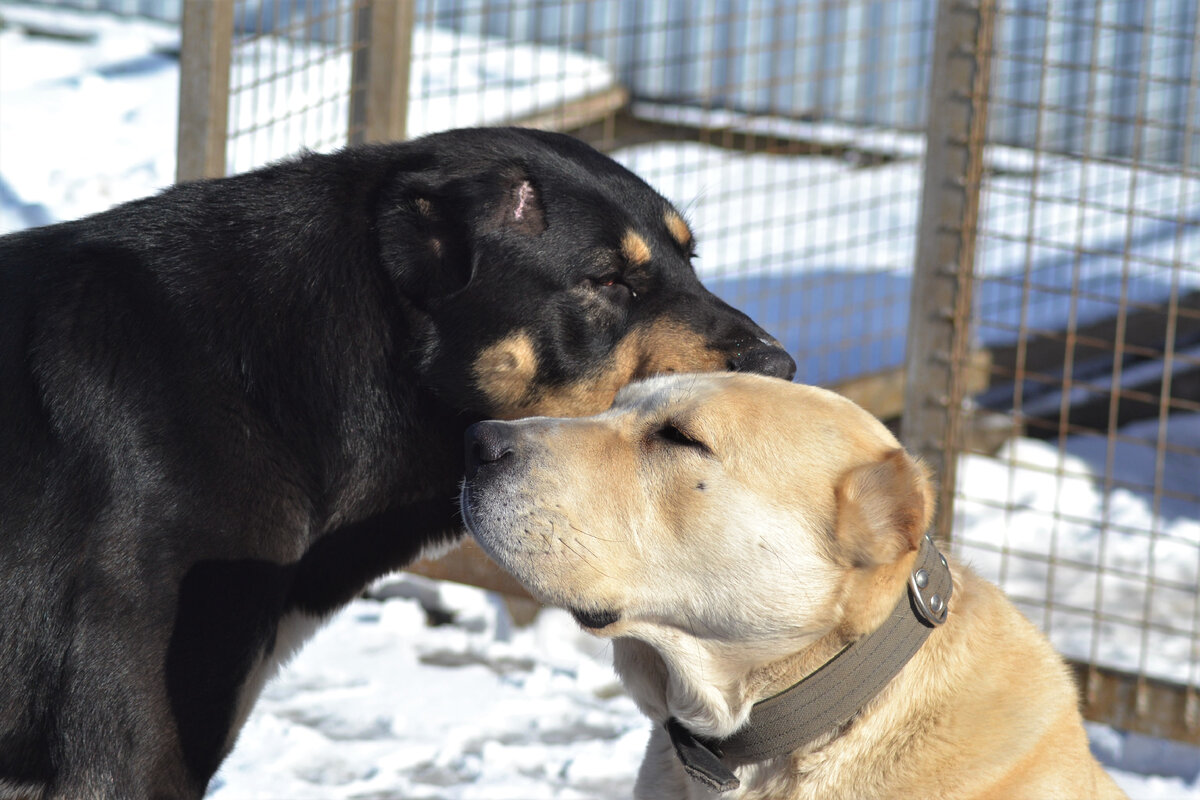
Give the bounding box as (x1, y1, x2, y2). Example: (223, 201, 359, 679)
(108, 0, 1200, 741)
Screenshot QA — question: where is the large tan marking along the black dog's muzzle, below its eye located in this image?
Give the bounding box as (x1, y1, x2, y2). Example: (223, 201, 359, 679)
(516, 320, 727, 416)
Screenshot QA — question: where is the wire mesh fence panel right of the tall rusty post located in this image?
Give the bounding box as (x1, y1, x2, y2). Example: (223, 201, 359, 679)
(954, 1, 1200, 741)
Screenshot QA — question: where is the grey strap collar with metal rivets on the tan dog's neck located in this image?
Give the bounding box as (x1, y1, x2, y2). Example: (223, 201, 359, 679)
(666, 534, 953, 792)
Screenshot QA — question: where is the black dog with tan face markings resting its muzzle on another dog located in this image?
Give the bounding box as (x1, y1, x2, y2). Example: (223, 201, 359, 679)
(0, 130, 794, 798)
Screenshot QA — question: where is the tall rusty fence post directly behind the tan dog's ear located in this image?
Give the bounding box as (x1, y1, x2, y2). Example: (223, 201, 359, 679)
(901, 0, 995, 540)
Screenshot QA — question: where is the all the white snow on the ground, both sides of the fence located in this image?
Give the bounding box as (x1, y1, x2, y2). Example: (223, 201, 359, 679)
(0, 2, 1200, 800)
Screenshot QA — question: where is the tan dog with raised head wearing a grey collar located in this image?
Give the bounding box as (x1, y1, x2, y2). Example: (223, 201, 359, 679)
(462, 374, 1123, 800)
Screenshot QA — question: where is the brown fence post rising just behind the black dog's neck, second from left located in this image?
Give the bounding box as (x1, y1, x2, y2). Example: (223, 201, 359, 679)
(349, 0, 416, 144)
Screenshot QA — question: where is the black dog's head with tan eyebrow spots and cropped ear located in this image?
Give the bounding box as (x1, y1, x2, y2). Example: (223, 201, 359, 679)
(379, 128, 796, 419)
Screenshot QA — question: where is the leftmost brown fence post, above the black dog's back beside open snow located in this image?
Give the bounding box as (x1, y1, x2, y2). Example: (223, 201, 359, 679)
(175, 0, 233, 181)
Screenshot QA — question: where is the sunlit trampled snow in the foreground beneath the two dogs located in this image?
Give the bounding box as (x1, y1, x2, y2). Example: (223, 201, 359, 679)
(210, 576, 1200, 800)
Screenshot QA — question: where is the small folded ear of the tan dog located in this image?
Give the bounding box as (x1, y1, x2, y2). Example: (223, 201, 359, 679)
(835, 449, 935, 567)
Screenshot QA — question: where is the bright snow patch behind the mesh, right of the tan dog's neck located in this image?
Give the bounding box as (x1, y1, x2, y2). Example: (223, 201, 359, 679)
(955, 414, 1200, 685)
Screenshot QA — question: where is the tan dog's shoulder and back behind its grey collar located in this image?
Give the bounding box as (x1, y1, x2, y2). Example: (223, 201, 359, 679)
(777, 559, 1124, 800)
